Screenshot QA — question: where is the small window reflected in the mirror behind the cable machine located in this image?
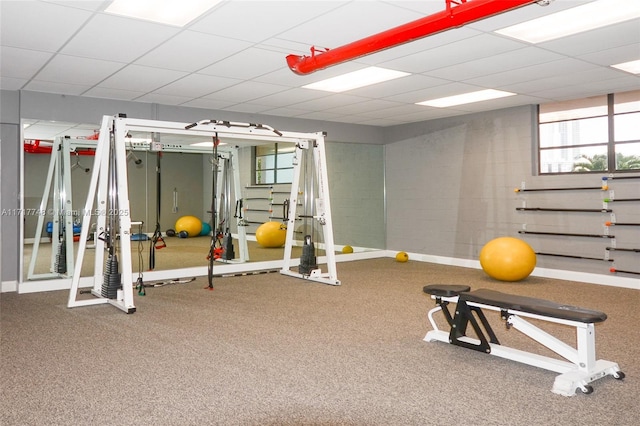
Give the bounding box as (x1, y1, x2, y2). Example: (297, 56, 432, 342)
(253, 143, 295, 185)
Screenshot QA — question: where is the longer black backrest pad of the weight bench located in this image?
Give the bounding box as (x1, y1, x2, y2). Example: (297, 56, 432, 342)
(460, 289, 607, 323)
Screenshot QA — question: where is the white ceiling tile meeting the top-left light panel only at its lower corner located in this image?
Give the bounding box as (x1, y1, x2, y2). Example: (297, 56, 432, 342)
(135, 31, 250, 72)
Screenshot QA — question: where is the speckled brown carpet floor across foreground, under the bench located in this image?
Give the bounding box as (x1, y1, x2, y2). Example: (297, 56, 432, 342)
(0, 259, 640, 426)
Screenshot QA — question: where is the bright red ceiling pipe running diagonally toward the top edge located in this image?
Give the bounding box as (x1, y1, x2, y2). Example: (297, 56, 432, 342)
(287, 0, 540, 75)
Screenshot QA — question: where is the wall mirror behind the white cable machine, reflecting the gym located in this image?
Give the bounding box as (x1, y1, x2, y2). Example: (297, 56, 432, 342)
(23, 116, 384, 281)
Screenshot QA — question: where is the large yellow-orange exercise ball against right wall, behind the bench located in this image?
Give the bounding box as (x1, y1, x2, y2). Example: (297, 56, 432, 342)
(480, 237, 536, 281)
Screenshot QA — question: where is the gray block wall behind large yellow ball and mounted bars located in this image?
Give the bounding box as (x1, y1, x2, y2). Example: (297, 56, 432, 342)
(385, 107, 640, 275)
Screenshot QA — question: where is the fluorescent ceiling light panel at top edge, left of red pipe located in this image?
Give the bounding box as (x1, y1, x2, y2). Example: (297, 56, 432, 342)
(105, 0, 219, 27)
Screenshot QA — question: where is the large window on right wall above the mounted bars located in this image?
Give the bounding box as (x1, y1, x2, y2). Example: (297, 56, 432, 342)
(538, 90, 640, 174)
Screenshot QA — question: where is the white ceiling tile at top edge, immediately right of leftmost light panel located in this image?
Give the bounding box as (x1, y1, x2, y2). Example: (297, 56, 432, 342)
(189, 1, 343, 42)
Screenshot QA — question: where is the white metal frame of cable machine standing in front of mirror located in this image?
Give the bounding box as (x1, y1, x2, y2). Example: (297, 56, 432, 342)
(67, 116, 340, 313)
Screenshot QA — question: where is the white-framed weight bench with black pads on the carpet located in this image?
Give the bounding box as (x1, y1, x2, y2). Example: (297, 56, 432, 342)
(423, 284, 625, 396)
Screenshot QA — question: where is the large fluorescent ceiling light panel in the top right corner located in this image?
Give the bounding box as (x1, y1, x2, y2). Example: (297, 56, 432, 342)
(496, 0, 640, 43)
